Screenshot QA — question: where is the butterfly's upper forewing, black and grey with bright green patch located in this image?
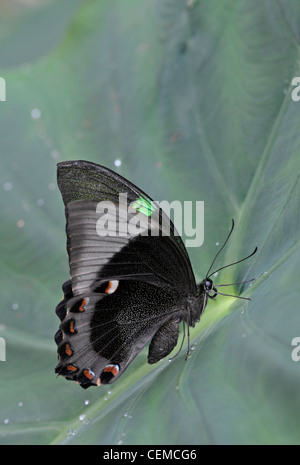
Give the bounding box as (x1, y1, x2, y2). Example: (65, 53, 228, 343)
(58, 161, 196, 295)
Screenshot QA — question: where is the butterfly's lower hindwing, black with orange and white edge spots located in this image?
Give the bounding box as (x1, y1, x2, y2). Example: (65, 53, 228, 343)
(56, 280, 184, 388)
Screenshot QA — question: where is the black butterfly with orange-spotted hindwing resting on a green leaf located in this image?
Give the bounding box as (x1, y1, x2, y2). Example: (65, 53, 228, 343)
(55, 161, 257, 388)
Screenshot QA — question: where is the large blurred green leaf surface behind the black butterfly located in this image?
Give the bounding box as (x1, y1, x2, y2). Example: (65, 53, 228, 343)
(0, 0, 300, 445)
